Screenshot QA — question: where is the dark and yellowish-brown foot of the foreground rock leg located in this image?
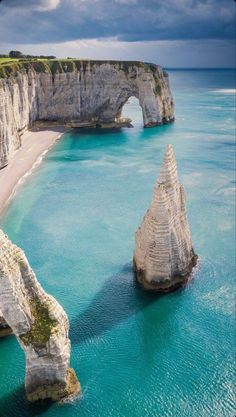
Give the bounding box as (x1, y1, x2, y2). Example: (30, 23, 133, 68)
(26, 368, 81, 403)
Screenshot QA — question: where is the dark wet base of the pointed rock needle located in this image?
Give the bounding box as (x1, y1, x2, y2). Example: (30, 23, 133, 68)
(133, 254, 198, 294)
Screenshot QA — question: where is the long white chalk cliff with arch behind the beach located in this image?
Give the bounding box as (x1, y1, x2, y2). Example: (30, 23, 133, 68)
(0, 61, 174, 167)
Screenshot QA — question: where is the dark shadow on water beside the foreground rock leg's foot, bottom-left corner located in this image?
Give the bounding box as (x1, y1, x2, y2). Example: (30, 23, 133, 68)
(0, 384, 53, 417)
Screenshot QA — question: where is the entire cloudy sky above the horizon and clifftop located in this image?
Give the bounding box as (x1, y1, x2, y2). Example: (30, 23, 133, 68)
(0, 0, 236, 67)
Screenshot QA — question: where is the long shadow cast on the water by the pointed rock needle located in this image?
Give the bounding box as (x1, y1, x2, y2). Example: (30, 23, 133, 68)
(70, 264, 161, 344)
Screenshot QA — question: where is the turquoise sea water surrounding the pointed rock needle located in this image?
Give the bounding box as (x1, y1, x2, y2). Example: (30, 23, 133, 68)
(0, 71, 235, 417)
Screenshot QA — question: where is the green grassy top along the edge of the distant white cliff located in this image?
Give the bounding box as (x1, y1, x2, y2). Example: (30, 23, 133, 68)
(0, 58, 160, 78)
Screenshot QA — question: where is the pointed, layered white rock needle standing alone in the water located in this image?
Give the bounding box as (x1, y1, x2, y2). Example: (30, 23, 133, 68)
(134, 145, 197, 292)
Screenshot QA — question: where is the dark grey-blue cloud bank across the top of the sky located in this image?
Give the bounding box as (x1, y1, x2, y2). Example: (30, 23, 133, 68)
(0, 0, 235, 43)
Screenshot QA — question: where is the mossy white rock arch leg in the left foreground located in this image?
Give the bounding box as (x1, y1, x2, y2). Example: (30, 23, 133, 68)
(0, 231, 80, 402)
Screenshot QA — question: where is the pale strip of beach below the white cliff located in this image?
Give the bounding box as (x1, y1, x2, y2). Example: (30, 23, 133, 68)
(0, 126, 68, 215)
